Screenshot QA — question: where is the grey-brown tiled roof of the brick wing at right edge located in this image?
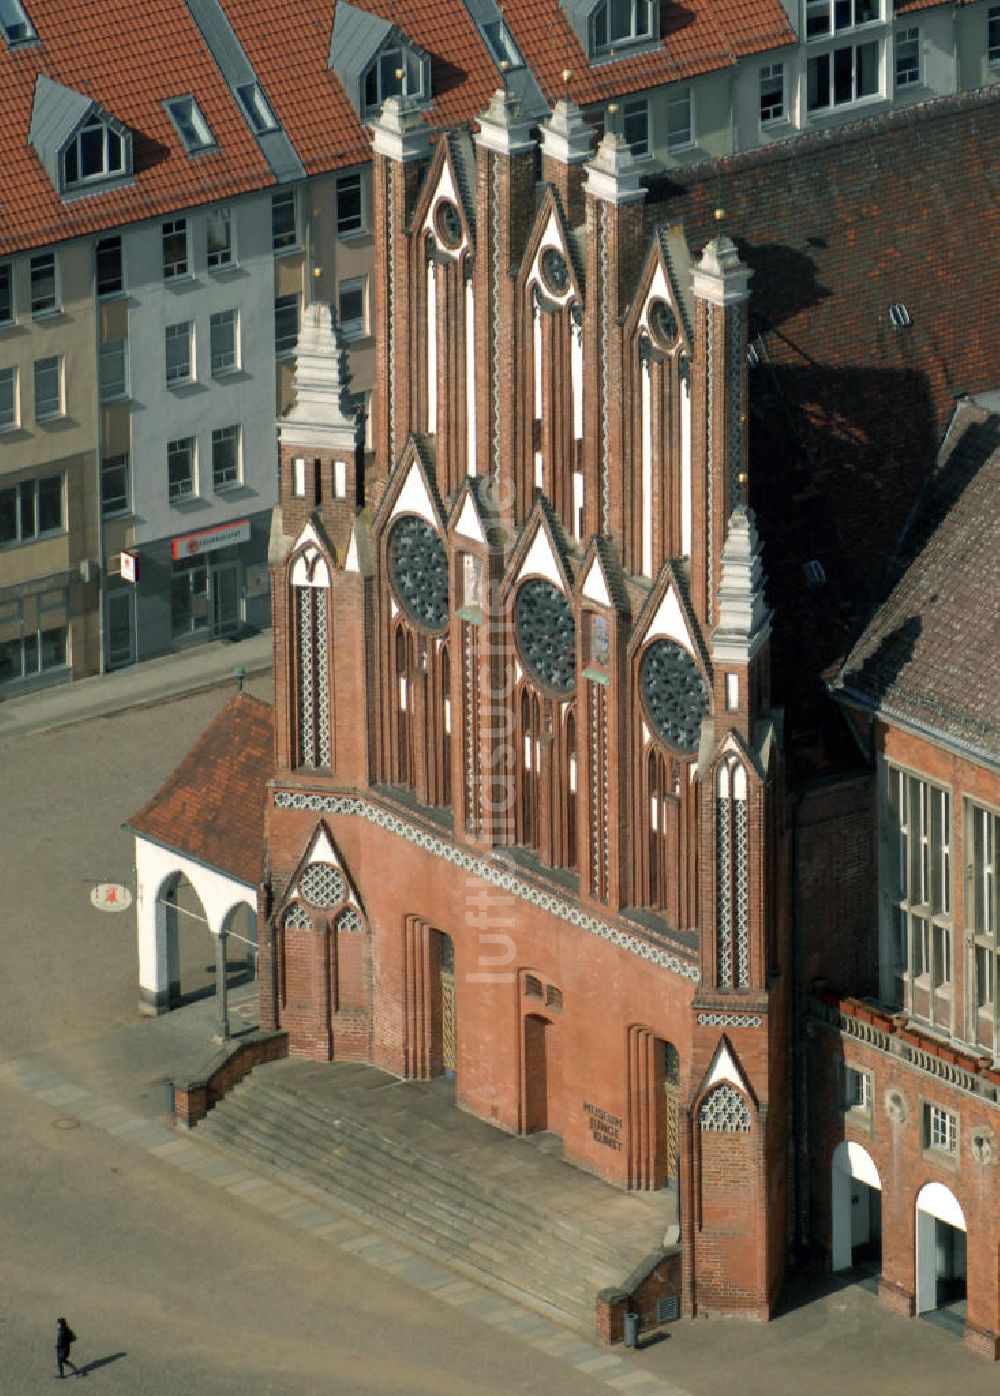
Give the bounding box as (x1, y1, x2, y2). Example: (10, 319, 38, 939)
(834, 402, 1000, 766)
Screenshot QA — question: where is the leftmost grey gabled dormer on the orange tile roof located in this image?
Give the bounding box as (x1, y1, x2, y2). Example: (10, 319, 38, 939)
(28, 74, 131, 197)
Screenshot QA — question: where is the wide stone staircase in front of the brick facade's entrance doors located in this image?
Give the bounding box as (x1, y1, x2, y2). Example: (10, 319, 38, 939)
(198, 1061, 676, 1335)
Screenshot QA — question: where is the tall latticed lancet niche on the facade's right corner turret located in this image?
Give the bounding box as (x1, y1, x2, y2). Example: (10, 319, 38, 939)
(715, 757, 750, 988)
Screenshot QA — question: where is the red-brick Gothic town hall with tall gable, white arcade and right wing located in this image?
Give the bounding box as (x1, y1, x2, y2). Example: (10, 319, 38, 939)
(131, 89, 1000, 1357)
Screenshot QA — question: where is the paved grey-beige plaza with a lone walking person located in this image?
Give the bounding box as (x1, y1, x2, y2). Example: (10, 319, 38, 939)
(0, 646, 997, 1396)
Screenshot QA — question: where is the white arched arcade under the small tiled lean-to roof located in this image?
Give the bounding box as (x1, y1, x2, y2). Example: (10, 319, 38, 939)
(135, 835, 257, 1018)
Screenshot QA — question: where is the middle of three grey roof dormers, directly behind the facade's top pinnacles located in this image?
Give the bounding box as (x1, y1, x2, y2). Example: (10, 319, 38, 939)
(328, 0, 430, 120)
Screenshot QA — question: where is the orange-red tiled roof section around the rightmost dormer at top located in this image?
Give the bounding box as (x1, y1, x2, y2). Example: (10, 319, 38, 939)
(503, 0, 796, 106)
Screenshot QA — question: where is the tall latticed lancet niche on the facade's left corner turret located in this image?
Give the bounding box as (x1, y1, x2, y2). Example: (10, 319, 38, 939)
(292, 549, 332, 769)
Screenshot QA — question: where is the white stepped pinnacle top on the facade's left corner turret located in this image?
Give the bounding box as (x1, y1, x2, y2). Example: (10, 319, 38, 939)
(281, 300, 358, 450)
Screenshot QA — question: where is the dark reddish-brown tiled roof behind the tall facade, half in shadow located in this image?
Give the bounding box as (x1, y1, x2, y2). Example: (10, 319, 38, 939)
(648, 91, 1000, 775)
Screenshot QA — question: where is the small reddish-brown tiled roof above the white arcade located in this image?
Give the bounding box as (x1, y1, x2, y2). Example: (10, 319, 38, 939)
(126, 694, 274, 884)
